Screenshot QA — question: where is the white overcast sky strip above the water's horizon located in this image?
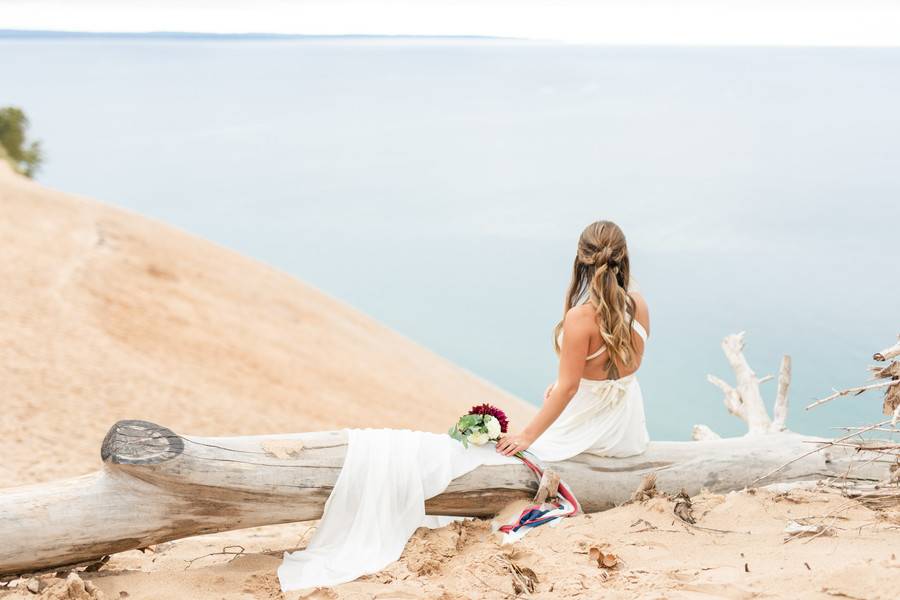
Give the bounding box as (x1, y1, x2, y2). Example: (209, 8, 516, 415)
(0, 0, 900, 47)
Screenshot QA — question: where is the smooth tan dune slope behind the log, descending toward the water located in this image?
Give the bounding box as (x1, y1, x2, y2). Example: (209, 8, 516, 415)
(0, 163, 534, 487)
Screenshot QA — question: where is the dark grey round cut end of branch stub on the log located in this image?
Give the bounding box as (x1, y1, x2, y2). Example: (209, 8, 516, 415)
(100, 419, 184, 465)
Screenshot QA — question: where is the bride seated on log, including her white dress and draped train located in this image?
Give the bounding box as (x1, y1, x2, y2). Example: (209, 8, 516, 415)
(278, 221, 649, 591)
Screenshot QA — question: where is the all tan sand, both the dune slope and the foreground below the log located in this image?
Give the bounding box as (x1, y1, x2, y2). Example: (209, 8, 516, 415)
(0, 164, 900, 600)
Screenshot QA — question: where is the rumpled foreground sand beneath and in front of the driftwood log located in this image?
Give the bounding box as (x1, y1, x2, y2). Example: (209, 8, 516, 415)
(0, 490, 900, 600)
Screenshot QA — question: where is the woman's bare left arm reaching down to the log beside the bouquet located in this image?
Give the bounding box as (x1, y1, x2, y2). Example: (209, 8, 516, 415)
(497, 307, 596, 456)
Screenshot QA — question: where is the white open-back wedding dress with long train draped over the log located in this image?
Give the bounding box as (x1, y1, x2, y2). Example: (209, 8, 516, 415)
(278, 320, 649, 591)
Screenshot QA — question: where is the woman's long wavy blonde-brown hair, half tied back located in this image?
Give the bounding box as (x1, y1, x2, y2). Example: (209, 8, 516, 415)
(553, 221, 636, 379)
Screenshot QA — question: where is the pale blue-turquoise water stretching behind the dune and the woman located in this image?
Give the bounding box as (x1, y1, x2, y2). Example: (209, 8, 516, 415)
(0, 39, 900, 439)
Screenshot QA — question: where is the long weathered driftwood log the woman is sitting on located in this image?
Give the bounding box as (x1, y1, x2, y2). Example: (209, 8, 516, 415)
(0, 336, 887, 577)
